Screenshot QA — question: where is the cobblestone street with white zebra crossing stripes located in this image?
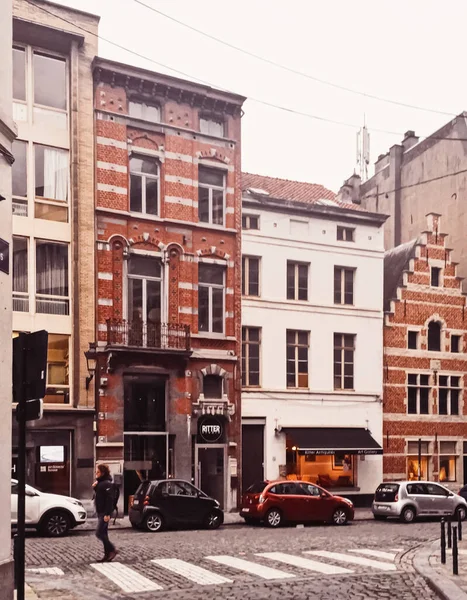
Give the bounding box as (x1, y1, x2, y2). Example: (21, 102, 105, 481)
(22, 521, 439, 600)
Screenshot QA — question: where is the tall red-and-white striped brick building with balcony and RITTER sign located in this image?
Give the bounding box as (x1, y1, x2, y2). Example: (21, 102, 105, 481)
(88, 59, 244, 510)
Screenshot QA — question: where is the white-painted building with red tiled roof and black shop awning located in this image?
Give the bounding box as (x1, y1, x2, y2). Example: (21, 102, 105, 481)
(242, 173, 386, 504)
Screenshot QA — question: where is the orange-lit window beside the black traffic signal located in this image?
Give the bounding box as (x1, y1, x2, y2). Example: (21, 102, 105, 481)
(44, 334, 70, 404)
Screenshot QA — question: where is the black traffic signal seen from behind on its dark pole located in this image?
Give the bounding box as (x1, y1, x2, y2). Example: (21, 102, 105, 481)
(13, 331, 48, 600)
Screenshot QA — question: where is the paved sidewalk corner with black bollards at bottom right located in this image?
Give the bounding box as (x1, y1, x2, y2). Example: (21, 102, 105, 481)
(413, 521, 467, 600)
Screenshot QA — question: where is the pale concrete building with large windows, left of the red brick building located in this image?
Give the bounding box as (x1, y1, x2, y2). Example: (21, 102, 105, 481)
(11, 0, 99, 498)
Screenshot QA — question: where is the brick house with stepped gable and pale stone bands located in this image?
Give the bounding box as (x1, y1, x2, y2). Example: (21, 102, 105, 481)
(383, 213, 467, 490)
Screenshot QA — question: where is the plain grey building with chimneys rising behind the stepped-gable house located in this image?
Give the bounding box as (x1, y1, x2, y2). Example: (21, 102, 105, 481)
(338, 113, 467, 291)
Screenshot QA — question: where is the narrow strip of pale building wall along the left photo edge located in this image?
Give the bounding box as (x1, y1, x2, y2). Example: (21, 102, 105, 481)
(0, 0, 16, 600)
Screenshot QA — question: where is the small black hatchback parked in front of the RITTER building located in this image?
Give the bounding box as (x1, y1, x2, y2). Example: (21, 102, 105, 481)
(129, 479, 224, 532)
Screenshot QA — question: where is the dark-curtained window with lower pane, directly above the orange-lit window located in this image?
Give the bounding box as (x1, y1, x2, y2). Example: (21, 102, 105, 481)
(36, 241, 70, 315)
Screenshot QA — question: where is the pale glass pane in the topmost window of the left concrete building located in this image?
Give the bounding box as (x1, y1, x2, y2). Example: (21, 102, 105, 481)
(34, 52, 67, 110)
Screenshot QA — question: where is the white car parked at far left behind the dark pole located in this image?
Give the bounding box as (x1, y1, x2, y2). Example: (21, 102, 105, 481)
(11, 479, 86, 537)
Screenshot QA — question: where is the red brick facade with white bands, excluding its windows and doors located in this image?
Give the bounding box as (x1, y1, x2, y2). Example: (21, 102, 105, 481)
(94, 59, 243, 508)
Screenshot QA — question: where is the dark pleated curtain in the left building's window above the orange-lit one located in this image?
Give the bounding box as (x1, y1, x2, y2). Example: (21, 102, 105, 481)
(36, 242, 68, 297)
